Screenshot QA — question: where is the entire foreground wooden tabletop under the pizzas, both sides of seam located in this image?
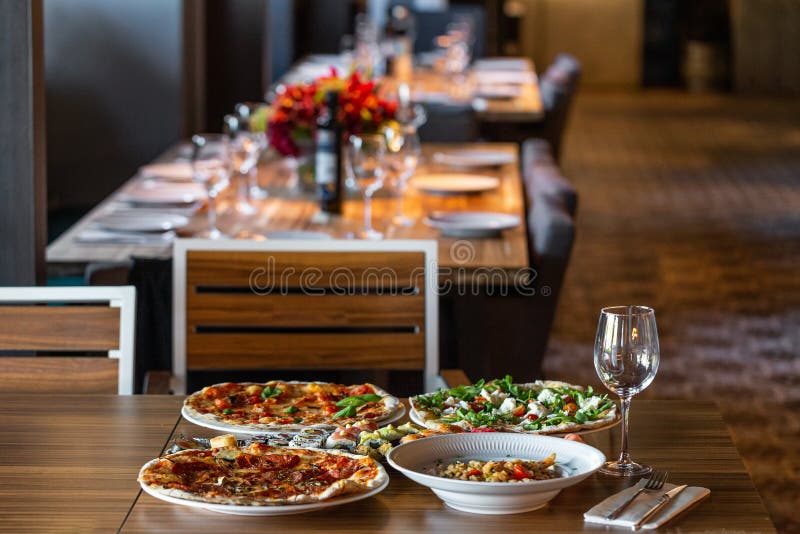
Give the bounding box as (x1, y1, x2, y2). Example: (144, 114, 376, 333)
(0, 391, 775, 533)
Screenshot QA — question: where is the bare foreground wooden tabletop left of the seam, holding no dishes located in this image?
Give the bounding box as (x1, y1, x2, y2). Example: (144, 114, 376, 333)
(0, 396, 181, 532)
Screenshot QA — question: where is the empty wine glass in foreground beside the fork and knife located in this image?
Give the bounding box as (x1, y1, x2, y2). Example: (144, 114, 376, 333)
(594, 306, 660, 477)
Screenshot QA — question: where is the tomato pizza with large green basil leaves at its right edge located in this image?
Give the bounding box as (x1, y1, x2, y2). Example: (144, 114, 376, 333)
(182, 380, 405, 434)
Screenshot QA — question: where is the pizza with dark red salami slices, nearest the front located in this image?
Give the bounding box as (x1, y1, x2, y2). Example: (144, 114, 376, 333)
(139, 443, 388, 506)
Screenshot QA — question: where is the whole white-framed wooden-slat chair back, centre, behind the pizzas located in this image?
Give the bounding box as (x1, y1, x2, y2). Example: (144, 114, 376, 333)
(173, 239, 442, 393)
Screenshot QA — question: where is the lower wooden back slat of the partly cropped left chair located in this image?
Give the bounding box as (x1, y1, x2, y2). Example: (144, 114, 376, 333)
(0, 356, 119, 395)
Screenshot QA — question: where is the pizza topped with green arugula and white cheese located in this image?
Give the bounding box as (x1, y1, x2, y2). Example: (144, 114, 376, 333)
(410, 376, 619, 434)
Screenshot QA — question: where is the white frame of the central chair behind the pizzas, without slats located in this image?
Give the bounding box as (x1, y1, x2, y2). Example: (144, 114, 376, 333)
(171, 239, 444, 395)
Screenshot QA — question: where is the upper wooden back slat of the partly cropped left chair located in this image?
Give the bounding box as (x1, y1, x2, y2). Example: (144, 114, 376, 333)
(0, 306, 120, 351)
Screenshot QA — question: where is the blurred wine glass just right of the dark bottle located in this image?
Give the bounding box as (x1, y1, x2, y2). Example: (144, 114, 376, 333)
(347, 134, 386, 239)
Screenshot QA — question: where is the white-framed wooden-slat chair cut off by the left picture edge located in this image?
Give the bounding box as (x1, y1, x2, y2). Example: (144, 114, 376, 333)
(0, 286, 136, 395)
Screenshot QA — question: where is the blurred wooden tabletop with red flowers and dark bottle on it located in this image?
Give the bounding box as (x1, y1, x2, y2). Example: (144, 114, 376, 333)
(47, 143, 529, 279)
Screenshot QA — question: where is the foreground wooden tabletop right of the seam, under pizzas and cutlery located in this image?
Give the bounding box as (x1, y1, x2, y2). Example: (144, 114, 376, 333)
(115, 400, 774, 534)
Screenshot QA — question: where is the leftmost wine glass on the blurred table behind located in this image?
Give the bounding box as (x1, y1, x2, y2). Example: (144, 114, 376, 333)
(192, 134, 231, 239)
